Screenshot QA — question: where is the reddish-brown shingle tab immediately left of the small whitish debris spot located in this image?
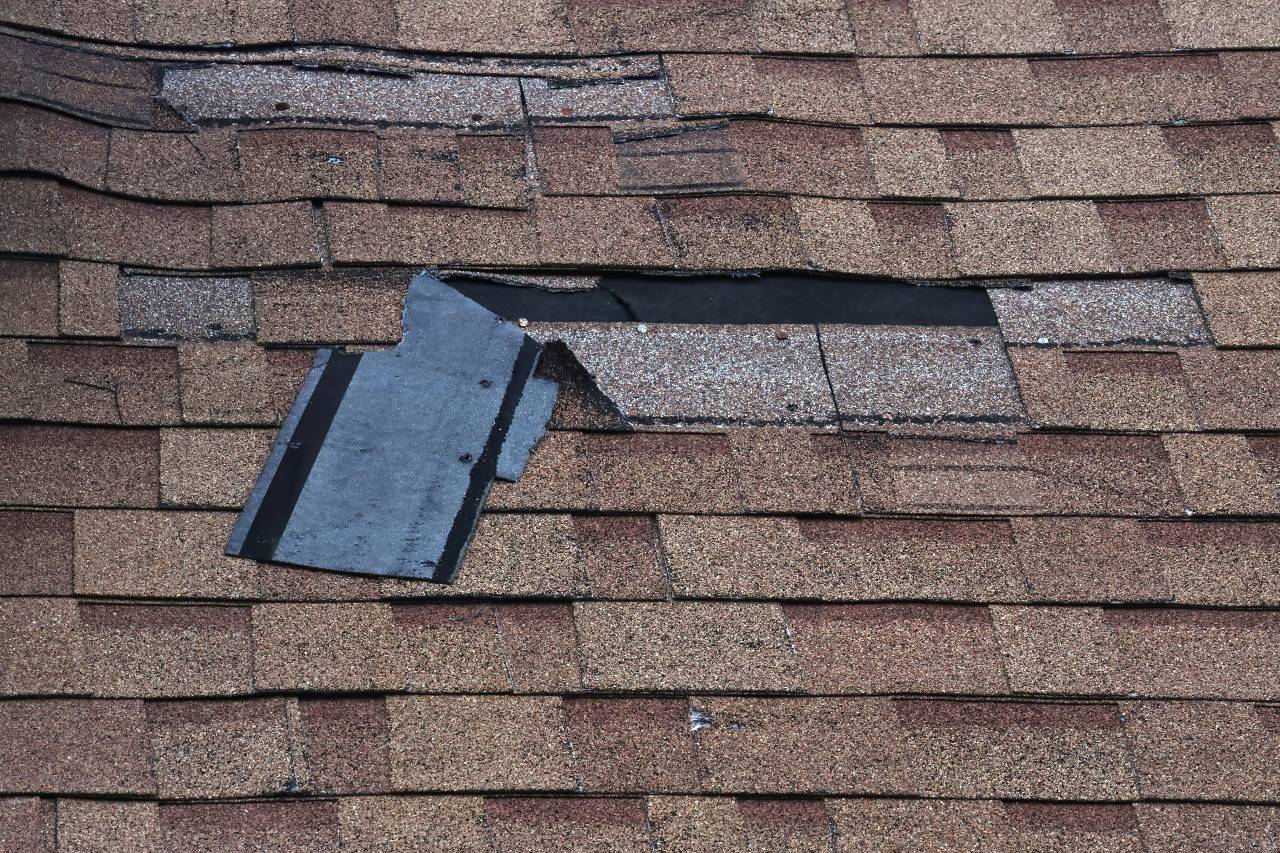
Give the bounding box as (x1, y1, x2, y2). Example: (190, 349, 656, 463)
(564, 698, 698, 792)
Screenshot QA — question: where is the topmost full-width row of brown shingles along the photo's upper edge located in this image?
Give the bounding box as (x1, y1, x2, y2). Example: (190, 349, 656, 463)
(5, 0, 1280, 55)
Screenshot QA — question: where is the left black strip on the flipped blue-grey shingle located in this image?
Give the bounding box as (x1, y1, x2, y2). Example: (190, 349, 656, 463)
(238, 350, 361, 561)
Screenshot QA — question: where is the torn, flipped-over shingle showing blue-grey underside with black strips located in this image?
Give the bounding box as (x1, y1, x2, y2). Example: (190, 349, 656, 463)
(227, 273, 557, 583)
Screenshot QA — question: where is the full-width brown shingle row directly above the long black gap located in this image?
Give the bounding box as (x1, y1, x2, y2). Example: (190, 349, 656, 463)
(10, 178, 1280, 272)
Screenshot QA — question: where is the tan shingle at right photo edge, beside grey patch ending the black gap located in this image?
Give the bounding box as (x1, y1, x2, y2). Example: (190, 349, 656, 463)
(1196, 273, 1280, 347)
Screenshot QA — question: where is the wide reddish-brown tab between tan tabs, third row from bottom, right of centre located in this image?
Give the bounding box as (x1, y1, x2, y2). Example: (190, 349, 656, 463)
(785, 605, 1007, 694)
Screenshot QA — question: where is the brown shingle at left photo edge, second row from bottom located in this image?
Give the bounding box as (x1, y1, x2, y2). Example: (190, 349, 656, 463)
(0, 699, 156, 795)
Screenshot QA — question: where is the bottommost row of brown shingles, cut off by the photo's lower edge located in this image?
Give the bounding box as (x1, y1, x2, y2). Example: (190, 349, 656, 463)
(0, 794, 1280, 853)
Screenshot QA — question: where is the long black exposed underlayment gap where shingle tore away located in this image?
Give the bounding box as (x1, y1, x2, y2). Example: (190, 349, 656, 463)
(451, 273, 996, 325)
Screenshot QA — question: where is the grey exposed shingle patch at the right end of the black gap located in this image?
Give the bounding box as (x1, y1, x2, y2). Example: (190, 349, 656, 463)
(988, 278, 1211, 345)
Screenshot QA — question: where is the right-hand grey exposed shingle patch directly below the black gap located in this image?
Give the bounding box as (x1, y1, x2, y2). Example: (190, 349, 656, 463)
(819, 325, 1023, 427)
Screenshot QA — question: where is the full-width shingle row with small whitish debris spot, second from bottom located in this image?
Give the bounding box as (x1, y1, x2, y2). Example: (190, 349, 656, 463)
(0, 695, 1280, 802)
